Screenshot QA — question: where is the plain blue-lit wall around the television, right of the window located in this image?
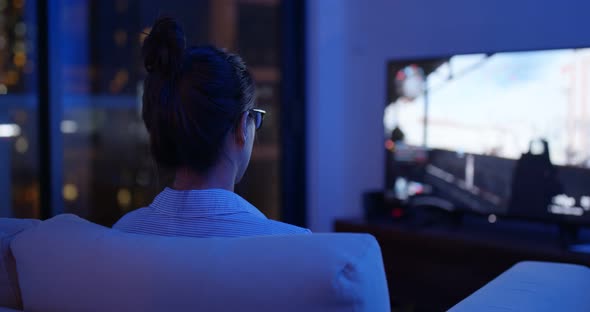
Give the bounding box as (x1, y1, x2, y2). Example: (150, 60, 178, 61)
(307, 0, 590, 231)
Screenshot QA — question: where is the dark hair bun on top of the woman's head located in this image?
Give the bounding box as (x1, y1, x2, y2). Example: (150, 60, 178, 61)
(141, 17, 186, 76)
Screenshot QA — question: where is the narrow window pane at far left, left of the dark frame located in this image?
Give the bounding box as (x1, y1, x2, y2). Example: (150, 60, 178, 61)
(0, 0, 39, 218)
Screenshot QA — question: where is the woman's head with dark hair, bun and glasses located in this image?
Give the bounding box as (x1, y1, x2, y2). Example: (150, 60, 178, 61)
(142, 18, 261, 183)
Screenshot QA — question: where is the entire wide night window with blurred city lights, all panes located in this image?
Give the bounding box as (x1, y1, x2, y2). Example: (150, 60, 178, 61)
(0, 0, 302, 226)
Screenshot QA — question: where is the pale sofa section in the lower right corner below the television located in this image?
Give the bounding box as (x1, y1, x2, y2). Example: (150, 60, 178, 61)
(450, 261, 590, 312)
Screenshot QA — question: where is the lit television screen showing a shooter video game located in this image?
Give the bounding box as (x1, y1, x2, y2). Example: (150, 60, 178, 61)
(383, 49, 590, 223)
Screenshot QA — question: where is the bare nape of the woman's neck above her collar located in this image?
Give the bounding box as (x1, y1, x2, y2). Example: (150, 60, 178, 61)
(172, 166, 235, 192)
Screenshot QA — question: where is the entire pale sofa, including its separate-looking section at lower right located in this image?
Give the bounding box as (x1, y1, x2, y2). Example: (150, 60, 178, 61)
(0, 215, 590, 312)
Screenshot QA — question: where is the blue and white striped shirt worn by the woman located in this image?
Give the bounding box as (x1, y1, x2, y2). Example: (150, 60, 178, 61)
(113, 188, 311, 237)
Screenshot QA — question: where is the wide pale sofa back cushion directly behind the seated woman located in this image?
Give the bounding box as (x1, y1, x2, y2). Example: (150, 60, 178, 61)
(12, 215, 389, 312)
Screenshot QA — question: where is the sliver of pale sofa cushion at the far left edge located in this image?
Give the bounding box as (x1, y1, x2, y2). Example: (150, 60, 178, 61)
(0, 218, 40, 309)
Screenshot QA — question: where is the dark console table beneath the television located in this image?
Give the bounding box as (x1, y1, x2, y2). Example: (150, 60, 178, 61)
(334, 217, 590, 311)
